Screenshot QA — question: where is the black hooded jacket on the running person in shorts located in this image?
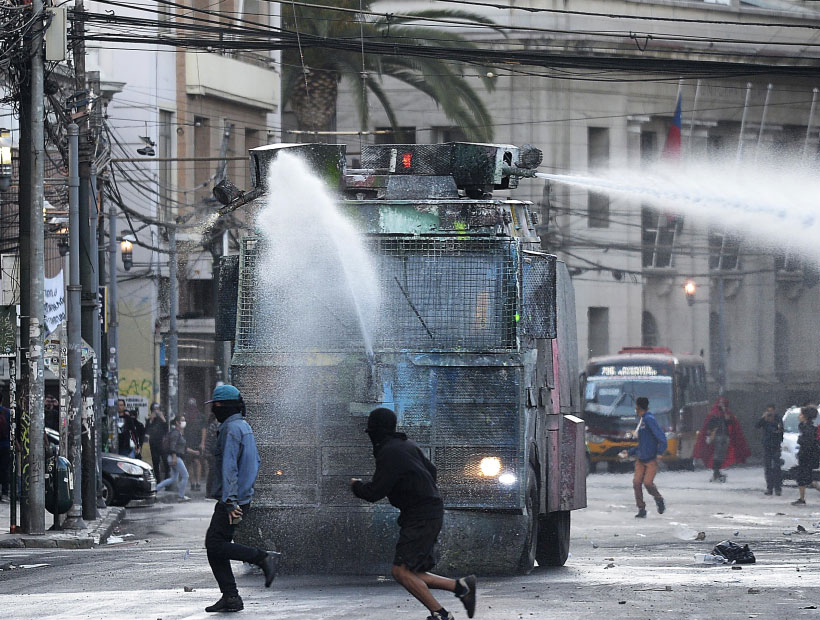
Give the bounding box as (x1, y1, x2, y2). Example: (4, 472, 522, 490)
(353, 433, 444, 525)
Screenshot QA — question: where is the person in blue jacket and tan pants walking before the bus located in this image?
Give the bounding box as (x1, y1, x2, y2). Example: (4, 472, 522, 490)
(629, 396, 666, 519)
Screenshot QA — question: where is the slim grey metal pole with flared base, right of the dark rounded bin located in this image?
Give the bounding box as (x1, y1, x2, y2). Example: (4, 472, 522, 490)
(63, 123, 86, 530)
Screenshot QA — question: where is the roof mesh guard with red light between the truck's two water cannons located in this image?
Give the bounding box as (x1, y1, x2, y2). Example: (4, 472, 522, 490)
(362, 144, 453, 176)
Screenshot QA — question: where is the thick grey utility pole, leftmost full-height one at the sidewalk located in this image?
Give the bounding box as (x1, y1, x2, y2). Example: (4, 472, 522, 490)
(20, 0, 45, 534)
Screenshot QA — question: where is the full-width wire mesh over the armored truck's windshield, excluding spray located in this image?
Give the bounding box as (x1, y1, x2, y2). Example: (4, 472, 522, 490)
(236, 236, 521, 352)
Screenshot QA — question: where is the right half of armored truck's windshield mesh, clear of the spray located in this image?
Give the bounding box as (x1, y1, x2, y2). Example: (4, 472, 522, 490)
(373, 237, 518, 351)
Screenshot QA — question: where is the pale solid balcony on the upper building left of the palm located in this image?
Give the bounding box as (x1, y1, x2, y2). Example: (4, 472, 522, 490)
(185, 52, 281, 112)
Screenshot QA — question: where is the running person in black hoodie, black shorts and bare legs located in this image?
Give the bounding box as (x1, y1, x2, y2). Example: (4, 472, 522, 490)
(350, 407, 476, 620)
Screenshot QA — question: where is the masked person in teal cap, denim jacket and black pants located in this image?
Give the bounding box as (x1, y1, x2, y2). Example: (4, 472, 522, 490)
(205, 384, 281, 612)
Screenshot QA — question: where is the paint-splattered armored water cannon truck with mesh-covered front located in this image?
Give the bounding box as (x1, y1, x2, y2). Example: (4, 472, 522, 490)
(215, 143, 586, 573)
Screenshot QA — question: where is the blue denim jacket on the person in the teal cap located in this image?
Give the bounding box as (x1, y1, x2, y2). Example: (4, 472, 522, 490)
(211, 413, 261, 506)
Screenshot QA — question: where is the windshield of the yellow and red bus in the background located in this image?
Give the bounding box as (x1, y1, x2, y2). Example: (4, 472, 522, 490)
(584, 377, 672, 418)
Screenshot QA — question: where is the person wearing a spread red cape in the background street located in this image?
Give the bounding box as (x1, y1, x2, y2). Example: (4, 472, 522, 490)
(692, 396, 752, 482)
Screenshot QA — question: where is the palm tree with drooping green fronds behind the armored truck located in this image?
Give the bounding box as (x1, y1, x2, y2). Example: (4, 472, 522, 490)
(282, 0, 495, 142)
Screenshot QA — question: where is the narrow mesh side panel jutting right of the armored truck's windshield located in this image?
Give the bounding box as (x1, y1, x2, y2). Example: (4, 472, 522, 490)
(521, 252, 556, 338)
